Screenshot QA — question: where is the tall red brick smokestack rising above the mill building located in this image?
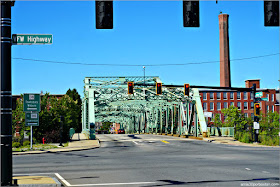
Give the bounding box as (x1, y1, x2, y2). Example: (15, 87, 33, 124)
(219, 14, 231, 87)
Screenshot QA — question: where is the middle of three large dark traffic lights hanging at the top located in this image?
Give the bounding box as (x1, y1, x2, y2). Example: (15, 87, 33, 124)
(183, 0, 199, 27)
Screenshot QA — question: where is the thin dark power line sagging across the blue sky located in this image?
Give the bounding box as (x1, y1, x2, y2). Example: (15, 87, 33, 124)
(12, 53, 280, 66)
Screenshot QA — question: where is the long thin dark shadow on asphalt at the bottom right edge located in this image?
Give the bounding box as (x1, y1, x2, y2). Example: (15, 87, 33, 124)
(143, 177, 280, 187)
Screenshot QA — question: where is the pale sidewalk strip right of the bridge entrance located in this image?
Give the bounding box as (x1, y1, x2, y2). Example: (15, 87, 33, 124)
(203, 136, 279, 148)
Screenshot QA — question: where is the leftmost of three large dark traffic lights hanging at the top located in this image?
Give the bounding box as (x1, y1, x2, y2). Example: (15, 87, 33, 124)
(95, 1, 113, 29)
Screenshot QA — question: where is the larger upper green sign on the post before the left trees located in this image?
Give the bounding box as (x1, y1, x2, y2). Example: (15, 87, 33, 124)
(23, 94, 41, 112)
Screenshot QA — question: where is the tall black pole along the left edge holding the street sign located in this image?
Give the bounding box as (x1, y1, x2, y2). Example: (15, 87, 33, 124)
(0, 1, 14, 186)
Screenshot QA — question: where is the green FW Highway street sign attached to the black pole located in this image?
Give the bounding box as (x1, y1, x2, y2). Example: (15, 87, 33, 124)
(12, 34, 53, 45)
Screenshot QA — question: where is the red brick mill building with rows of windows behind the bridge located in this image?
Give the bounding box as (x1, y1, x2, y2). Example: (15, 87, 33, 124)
(199, 79, 279, 121)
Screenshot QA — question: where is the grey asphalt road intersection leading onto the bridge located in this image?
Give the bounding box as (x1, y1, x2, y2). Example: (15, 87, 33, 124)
(13, 134, 280, 187)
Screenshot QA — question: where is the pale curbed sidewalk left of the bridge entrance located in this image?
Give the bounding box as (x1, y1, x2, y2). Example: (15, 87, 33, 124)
(13, 133, 100, 155)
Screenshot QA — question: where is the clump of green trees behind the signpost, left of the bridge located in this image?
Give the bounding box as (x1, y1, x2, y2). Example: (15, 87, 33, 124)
(12, 93, 81, 142)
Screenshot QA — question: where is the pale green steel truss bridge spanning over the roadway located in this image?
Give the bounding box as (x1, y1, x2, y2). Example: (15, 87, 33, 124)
(82, 76, 207, 139)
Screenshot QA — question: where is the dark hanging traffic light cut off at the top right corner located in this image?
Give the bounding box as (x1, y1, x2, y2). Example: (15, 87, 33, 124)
(264, 0, 279, 26)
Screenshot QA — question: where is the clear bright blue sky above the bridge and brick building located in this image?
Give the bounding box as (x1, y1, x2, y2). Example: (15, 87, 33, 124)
(12, 1, 279, 96)
